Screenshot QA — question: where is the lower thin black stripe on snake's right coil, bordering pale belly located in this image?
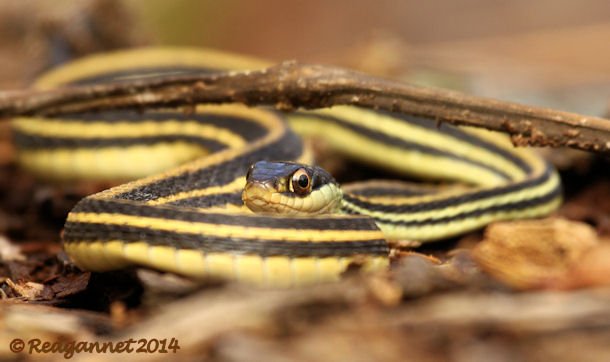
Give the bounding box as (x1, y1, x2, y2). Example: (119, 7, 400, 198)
(356, 188, 562, 226)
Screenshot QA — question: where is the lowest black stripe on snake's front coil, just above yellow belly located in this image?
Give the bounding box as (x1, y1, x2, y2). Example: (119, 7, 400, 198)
(64, 223, 388, 257)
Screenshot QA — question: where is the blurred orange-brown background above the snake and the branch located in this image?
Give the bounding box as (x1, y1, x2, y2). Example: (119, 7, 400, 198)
(0, 0, 610, 115)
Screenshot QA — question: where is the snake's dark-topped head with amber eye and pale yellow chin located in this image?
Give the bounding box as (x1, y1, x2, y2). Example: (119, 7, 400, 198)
(242, 161, 343, 215)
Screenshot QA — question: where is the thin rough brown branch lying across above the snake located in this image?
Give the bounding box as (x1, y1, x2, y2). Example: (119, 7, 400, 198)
(0, 62, 610, 153)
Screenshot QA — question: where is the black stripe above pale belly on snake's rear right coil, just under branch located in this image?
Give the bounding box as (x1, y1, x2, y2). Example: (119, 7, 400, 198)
(304, 114, 511, 180)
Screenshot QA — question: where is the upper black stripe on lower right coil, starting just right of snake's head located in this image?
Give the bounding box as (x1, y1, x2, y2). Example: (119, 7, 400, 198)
(343, 164, 553, 214)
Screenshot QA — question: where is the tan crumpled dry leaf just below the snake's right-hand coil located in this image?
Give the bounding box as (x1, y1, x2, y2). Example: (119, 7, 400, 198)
(473, 218, 598, 289)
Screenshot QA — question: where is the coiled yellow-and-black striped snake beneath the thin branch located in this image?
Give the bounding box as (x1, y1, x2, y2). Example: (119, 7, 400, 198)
(11, 47, 562, 288)
